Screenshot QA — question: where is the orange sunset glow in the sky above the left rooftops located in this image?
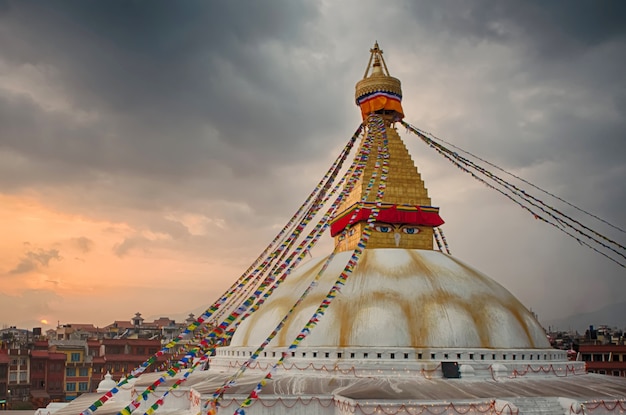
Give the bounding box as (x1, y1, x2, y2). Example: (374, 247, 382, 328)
(0, 195, 239, 326)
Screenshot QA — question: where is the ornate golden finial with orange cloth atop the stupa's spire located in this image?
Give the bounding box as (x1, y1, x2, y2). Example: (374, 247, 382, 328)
(355, 41, 404, 121)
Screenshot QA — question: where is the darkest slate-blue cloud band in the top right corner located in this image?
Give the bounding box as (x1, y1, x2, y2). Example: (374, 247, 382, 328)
(409, 0, 626, 60)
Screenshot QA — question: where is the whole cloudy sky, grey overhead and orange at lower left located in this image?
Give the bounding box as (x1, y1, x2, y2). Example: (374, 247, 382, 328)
(0, 0, 626, 328)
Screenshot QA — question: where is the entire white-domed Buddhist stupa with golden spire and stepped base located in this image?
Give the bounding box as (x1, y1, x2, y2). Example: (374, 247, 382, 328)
(58, 44, 626, 415)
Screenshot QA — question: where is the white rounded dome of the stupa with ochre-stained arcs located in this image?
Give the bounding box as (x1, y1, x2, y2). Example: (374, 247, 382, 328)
(231, 248, 550, 349)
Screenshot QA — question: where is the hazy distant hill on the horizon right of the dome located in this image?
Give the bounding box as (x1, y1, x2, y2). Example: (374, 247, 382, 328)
(541, 302, 626, 333)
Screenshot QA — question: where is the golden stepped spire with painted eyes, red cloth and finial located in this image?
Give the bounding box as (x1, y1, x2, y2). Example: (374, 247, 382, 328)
(331, 42, 443, 251)
